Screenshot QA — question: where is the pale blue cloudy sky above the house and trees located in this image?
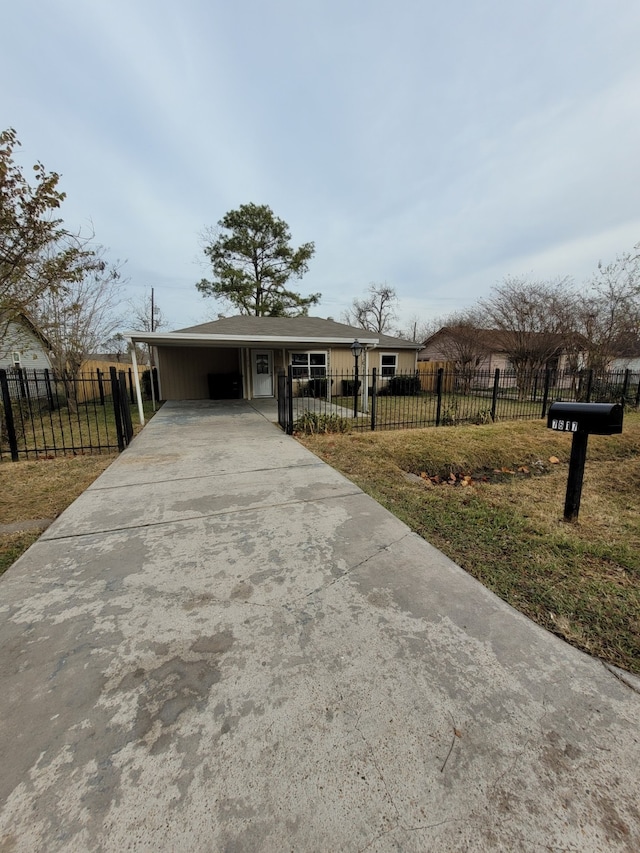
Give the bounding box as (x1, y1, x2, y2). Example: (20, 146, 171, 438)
(5, 0, 640, 329)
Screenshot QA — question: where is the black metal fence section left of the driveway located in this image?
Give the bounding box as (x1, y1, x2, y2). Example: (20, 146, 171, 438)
(0, 367, 135, 462)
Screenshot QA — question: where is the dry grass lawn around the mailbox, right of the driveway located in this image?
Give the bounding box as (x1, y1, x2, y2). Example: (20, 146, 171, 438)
(301, 414, 640, 672)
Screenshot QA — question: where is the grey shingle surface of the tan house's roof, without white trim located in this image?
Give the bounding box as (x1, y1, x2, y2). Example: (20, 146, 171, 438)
(175, 314, 420, 349)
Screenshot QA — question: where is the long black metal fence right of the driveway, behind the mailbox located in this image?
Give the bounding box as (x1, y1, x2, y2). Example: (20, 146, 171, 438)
(278, 364, 640, 433)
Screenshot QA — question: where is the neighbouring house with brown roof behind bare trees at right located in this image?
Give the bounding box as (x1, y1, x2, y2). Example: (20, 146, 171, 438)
(418, 326, 580, 372)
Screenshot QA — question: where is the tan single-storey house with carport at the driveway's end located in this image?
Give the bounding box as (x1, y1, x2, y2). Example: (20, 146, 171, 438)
(125, 315, 419, 400)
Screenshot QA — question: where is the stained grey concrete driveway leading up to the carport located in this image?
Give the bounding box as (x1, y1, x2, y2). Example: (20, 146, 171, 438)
(0, 401, 640, 853)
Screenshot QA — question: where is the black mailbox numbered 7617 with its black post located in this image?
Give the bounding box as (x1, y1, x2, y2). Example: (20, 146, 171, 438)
(547, 403, 624, 521)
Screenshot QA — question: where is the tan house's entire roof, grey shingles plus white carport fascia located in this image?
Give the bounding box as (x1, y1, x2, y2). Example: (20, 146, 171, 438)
(125, 315, 420, 349)
